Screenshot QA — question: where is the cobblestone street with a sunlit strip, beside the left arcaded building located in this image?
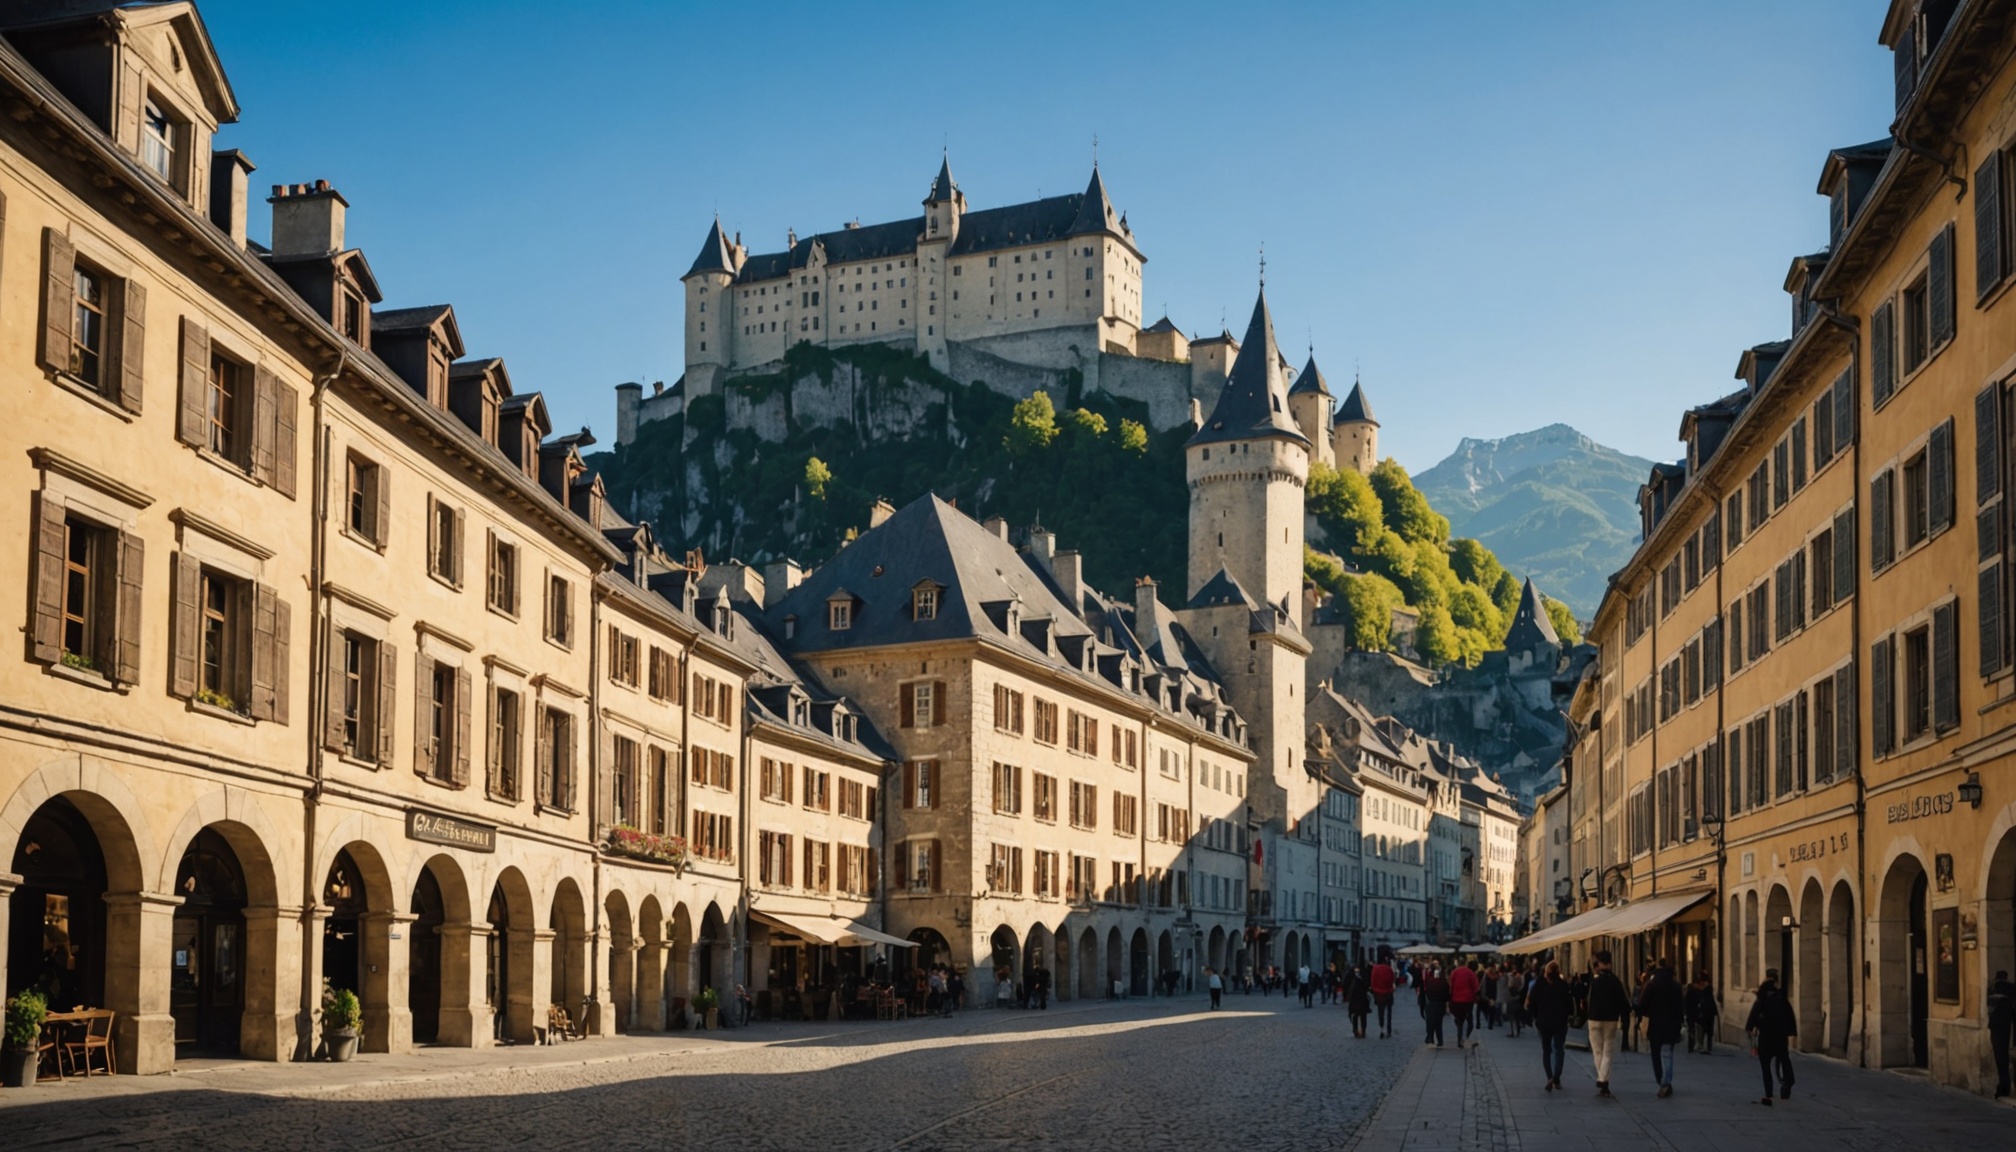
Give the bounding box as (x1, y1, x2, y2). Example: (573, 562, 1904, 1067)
(0, 997, 1415, 1152)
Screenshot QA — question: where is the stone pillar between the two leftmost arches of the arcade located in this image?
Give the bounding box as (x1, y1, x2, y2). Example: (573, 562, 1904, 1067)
(105, 892, 181, 1075)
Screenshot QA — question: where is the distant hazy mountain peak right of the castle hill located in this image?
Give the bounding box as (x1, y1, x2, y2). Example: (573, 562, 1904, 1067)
(1413, 424, 1651, 619)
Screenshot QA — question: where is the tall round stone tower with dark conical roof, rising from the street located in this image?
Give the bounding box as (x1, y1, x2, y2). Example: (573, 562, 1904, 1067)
(1181, 293, 1320, 839)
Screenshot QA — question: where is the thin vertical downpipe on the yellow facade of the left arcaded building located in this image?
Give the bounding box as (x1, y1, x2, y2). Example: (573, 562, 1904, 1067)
(294, 345, 351, 1061)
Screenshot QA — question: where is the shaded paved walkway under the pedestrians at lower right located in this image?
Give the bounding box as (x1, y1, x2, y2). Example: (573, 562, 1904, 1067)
(1353, 1031, 2016, 1152)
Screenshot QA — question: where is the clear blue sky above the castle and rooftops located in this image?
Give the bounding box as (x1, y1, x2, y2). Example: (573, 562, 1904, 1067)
(202, 0, 1891, 470)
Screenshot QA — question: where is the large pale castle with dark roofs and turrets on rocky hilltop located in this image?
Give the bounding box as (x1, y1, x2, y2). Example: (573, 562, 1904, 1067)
(617, 157, 1379, 459)
